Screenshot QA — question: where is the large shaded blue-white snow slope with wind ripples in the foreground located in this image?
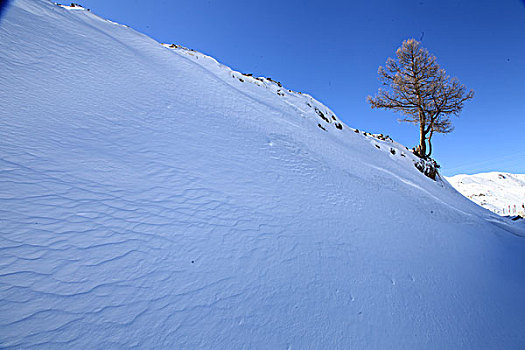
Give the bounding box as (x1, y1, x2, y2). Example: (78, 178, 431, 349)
(0, 0, 525, 349)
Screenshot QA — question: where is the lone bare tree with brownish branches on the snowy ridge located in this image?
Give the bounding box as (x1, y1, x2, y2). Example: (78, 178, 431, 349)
(368, 39, 474, 158)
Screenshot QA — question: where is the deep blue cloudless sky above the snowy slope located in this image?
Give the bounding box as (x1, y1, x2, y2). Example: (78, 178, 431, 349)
(75, 0, 525, 175)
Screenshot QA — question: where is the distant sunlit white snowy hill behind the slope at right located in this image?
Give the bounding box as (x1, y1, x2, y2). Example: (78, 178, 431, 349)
(447, 172, 525, 215)
